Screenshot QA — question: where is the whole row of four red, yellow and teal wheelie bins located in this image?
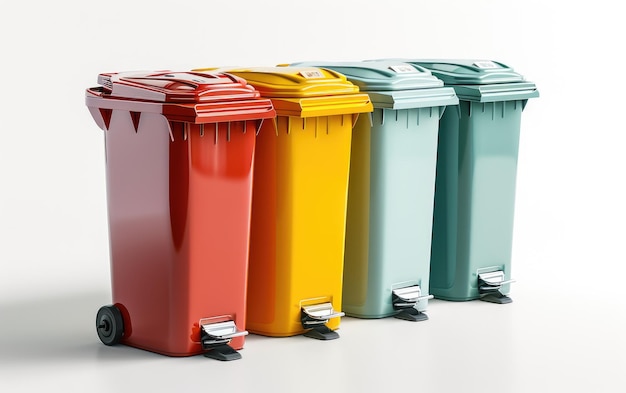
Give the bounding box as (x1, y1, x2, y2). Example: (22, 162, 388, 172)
(86, 59, 538, 360)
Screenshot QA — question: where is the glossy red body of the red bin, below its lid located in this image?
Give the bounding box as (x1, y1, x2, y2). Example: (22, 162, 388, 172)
(105, 110, 255, 356)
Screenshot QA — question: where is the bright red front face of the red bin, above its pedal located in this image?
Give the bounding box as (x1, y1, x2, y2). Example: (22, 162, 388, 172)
(181, 121, 255, 349)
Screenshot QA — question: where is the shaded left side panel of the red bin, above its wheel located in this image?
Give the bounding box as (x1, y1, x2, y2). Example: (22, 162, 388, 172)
(104, 110, 171, 353)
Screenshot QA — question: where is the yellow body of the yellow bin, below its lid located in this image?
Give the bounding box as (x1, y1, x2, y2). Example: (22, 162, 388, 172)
(247, 114, 353, 336)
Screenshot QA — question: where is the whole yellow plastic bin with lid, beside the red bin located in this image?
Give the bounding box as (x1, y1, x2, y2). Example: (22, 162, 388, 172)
(195, 67, 373, 340)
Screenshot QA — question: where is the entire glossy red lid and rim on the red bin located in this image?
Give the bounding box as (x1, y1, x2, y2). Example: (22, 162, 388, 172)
(85, 71, 276, 129)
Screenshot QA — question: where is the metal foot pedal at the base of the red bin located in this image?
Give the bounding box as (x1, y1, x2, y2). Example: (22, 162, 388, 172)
(200, 321, 248, 361)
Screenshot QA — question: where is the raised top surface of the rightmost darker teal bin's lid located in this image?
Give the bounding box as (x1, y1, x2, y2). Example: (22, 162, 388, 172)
(404, 60, 524, 85)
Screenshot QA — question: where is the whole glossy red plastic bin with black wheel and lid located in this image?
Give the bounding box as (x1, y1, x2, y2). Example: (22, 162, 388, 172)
(86, 72, 275, 360)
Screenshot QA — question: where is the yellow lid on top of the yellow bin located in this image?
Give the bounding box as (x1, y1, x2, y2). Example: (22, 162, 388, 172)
(194, 67, 373, 117)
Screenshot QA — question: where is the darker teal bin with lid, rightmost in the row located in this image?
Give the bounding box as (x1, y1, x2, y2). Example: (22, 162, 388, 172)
(404, 59, 539, 303)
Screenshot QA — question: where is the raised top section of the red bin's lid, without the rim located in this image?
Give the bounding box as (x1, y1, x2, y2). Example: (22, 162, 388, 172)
(98, 71, 259, 103)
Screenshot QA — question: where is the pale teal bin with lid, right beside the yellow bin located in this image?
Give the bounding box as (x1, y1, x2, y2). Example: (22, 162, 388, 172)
(292, 61, 458, 321)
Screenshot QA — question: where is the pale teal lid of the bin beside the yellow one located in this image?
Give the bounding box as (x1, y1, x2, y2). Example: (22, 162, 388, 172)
(290, 60, 458, 109)
